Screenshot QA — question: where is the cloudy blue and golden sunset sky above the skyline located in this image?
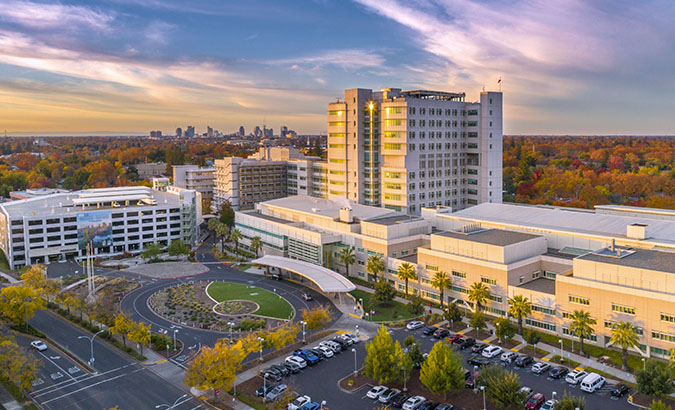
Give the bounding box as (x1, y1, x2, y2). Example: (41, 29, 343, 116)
(0, 0, 675, 135)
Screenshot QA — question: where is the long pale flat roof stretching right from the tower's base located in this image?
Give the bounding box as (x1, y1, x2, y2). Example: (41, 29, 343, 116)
(448, 202, 675, 245)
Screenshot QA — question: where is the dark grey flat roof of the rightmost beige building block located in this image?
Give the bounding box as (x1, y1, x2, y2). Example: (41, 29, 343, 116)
(577, 248, 675, 273)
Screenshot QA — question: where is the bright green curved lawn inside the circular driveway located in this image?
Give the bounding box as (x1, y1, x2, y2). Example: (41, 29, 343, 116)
(207, 282, 293, 319)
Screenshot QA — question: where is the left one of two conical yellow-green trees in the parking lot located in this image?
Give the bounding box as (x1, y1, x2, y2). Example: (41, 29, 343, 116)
(363, 326, 406, 384)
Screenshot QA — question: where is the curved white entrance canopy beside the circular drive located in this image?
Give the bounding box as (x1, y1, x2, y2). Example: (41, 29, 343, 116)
(252, 255, 356, 293)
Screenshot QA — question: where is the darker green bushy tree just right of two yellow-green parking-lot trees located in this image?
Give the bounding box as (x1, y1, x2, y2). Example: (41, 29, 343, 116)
(478, 365, 524, 409)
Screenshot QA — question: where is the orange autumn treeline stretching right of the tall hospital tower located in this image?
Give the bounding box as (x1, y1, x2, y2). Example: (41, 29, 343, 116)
(504, 136, 675, 209)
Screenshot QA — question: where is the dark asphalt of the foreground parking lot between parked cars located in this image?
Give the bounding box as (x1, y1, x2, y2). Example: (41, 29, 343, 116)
(252, 329, 633, 410)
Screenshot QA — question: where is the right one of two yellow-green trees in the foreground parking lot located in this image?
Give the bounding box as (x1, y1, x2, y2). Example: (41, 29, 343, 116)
(420, 343, 465, 397)
